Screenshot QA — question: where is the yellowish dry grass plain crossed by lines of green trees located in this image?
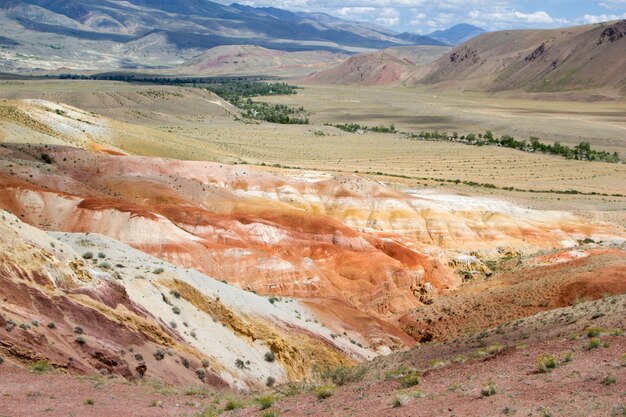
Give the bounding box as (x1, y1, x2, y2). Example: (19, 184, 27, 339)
(0, 81, 626, 226)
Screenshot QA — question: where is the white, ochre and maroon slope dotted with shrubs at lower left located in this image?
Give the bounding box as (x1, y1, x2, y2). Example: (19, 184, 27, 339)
(0, 211, 380, 390)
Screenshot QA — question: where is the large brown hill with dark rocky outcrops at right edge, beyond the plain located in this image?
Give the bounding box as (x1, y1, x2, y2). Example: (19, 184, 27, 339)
(407, 21, 626, 94)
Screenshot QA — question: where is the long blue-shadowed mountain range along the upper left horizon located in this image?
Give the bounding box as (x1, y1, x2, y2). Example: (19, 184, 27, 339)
(0, 0, 482, 72)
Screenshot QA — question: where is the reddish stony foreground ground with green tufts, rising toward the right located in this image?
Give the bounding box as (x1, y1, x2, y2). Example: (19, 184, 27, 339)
(0, 296, 626, 417)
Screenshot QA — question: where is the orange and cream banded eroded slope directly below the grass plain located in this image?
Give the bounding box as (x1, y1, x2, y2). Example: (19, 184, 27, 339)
(0, 145, 624, 319)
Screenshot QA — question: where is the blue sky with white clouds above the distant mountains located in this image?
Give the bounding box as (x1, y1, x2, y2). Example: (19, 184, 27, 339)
(220, 0, 626, 34)
